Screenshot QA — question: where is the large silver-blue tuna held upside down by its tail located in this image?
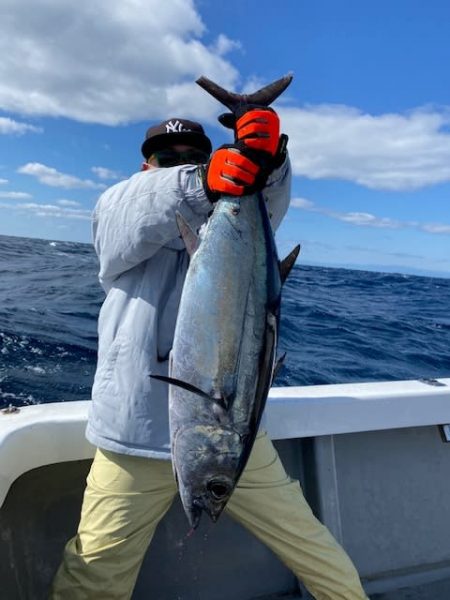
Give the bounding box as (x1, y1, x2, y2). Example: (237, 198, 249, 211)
(154, 77, 299, 528)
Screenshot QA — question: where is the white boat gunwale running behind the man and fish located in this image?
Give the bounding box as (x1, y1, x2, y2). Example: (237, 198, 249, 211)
(0, 378, 450, 507)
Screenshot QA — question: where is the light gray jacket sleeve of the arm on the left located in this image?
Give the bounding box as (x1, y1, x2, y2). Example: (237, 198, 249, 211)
(93, 166, 212, 288)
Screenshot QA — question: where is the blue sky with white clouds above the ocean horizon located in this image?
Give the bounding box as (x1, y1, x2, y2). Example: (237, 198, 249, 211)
(0, 0, 450, 276)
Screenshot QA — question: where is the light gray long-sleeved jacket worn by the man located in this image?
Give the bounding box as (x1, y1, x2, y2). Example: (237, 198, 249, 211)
(86, 160, 291, 459)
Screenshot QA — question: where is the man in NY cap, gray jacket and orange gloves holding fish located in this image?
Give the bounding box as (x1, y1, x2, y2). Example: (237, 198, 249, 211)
(50, 107, 366, 600)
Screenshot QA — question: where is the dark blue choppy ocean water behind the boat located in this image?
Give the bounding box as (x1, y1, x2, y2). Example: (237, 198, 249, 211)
(0, 236, 450, 408)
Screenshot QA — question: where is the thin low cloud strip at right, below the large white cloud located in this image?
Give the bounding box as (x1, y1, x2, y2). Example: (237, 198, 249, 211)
(291, 198, 450, 234)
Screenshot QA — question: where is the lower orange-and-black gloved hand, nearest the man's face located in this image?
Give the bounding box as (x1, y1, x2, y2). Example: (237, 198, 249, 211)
(205, 142, 268, 202)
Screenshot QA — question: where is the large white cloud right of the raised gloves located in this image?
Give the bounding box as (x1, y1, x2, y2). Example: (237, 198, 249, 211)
(279, 106, 450, 190)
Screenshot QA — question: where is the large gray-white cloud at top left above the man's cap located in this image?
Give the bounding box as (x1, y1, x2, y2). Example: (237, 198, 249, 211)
(0, 0, 238, 125)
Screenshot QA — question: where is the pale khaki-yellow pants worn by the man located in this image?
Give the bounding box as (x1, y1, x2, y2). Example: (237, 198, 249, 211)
(50, 434, 367, 600)
